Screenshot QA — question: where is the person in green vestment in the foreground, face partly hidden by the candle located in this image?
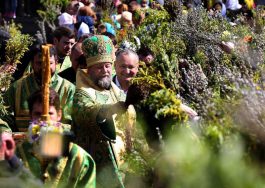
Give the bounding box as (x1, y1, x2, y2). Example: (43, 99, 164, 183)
(17, 89, 96, 188)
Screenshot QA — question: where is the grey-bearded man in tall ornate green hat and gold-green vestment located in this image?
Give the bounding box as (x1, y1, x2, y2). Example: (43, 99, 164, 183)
(72, 35, 135, 187)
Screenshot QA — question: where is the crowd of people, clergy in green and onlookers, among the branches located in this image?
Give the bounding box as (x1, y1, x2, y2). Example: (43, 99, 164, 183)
(0, 0, 264, 187)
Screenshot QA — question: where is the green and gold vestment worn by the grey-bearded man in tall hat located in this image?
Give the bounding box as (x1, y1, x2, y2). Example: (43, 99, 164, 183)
(72, 70, 135, 187)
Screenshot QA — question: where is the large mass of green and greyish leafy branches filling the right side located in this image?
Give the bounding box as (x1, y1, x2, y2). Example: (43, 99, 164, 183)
(125, 1, 265, 187)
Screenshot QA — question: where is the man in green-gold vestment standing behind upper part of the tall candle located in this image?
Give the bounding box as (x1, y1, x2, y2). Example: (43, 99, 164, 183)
(0, 44, 75, 132)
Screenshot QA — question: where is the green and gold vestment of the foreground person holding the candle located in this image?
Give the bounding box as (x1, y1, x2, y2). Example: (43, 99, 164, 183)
(17, 141, 96, 188)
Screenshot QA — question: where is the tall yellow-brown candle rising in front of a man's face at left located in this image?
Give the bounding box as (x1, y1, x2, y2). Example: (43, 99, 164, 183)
(41, 45, 51, 121)
